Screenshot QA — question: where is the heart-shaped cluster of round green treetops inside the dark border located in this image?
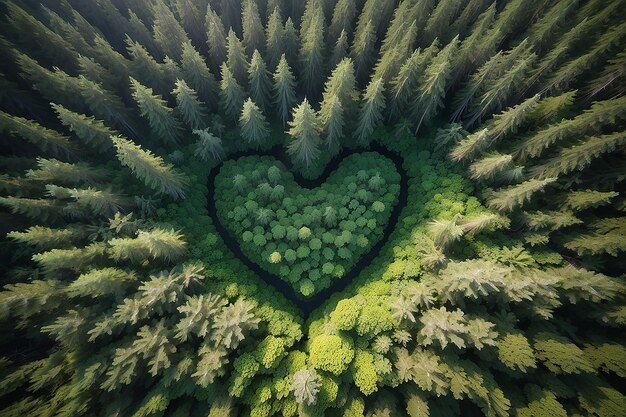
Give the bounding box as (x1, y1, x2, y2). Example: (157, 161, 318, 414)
(214, 152, 400, 297)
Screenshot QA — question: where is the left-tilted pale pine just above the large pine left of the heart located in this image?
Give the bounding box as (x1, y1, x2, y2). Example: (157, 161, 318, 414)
(130, 77, 182, 143)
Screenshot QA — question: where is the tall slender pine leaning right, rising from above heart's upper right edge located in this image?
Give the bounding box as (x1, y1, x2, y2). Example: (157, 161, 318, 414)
(412, 36, 459, 134)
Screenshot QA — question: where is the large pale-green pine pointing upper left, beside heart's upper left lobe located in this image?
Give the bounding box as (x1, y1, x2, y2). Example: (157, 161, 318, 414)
(111, 136, 186, 199)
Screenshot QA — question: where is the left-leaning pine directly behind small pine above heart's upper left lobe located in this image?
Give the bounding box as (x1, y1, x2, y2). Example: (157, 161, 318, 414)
(181, 42, 217, 104)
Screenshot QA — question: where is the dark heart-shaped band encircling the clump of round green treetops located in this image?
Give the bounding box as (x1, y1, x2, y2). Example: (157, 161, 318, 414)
(207, 143, 409, 318)
